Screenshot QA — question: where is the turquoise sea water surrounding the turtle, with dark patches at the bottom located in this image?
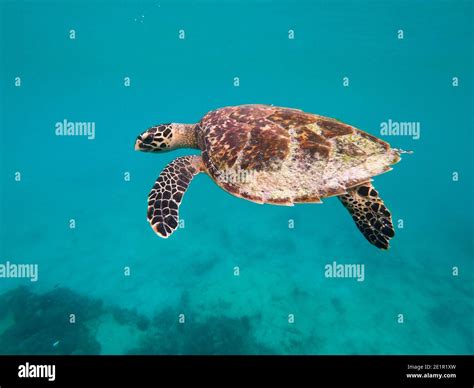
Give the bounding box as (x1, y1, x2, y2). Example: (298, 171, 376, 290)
(0, 1, 474, 354)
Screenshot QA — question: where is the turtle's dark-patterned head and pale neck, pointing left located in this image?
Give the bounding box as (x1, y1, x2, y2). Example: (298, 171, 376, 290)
(135, 123, 197, 152)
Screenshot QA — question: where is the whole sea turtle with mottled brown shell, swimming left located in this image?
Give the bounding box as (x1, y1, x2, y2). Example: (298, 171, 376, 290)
(135, 105, 403, 249)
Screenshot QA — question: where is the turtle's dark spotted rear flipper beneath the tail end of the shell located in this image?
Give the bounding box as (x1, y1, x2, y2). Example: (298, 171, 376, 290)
(339, 182, 395, 249)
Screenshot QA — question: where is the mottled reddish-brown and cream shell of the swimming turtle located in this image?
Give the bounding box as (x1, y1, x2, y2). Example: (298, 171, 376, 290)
(197, 105, 400, 205)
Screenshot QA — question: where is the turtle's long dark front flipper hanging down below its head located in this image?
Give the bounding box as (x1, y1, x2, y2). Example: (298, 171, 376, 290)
(147, 155, 203, 238)
